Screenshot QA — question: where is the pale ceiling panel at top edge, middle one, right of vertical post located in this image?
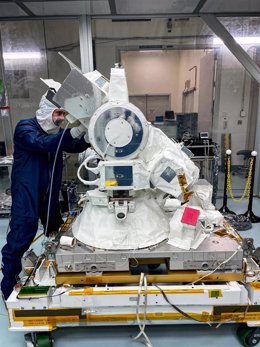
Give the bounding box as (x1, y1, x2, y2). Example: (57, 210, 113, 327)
(116, 0, 199, 14)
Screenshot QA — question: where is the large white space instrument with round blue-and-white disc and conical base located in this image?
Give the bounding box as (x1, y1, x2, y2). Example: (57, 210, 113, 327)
(54, 68, 215, 250)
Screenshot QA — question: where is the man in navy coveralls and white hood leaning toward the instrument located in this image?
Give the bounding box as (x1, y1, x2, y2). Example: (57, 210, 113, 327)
(1, 96, 90, 300)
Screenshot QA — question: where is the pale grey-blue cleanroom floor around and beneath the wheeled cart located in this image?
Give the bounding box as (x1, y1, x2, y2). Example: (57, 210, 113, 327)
(0, 199, 260, 347)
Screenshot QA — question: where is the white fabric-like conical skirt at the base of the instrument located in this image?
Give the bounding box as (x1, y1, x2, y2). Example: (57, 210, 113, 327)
(72, 194, 169, 250)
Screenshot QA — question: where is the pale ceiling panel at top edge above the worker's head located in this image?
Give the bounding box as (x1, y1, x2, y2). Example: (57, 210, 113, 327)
(24, 0, 110, 16)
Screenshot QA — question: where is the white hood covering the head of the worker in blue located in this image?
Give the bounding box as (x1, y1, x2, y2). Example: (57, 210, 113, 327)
(36, 94, 60, 134)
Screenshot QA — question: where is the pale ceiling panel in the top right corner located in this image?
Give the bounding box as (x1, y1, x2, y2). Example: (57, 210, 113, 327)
(201, 0, 260, 13)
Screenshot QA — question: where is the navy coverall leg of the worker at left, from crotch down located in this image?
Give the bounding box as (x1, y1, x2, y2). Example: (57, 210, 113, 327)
(1, 217, 38, 300)
